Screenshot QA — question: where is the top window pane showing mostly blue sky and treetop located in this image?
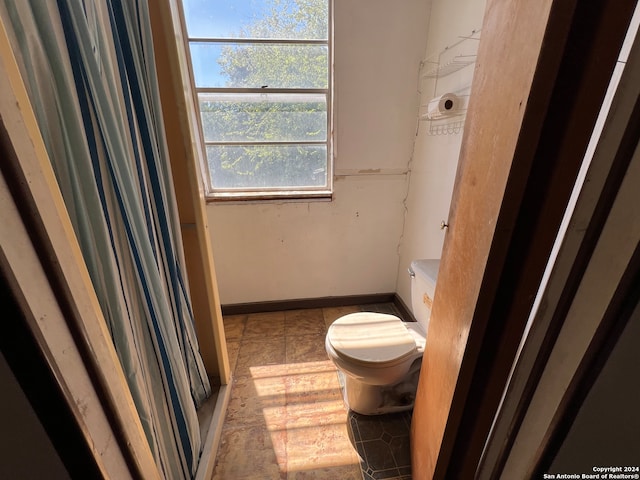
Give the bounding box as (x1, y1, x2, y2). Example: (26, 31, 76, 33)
(183, 0, 329, 40)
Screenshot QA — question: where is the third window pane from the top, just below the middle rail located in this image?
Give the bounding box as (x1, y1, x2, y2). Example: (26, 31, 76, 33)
(198, 93, 327, 142)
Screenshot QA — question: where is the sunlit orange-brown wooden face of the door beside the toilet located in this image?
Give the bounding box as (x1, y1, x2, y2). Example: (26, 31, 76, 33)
(411, 0, 551, 479)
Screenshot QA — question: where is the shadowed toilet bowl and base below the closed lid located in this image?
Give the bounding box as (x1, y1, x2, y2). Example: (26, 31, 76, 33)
(338, 359, 421, 415)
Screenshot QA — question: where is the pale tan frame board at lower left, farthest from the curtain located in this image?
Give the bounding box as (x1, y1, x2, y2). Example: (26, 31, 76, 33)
(0, 164, 124, 479)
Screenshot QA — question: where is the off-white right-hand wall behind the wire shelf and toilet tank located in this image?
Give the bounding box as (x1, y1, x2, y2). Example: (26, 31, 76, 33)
(396, 0, 485, 305)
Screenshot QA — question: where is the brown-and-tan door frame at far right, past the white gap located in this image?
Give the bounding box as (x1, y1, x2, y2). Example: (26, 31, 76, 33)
(476, 11, 640, 479)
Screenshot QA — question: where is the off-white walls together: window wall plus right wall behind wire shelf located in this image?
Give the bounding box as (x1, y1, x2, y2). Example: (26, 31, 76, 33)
(208, 0, 485, 305)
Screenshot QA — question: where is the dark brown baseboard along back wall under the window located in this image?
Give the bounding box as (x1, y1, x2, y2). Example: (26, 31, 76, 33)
(222, 293, 398, 315)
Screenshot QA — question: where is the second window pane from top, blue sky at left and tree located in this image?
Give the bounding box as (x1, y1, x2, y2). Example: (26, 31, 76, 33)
(190, 42, 329, 88)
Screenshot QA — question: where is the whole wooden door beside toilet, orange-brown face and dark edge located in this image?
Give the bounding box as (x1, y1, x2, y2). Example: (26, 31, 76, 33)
(411, 0, 636, 479)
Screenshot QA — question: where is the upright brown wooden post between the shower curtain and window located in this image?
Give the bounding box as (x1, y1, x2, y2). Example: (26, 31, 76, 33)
(149, 0, 231, 385)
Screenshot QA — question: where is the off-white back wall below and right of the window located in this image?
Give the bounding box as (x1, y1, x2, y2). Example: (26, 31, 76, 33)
(207, 0, 431, 304)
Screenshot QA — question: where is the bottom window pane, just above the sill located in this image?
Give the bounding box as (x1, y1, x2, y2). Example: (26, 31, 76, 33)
(207, 145, 327, 189)
